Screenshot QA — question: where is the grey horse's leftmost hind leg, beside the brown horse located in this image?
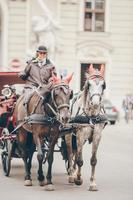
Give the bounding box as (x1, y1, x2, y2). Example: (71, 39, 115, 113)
(65, 134, 74, 183)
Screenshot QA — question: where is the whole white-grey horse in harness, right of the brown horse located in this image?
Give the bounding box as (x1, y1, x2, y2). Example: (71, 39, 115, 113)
(65, 65, 106, 191)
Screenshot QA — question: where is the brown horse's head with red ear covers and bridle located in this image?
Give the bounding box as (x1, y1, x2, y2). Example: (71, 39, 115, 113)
(48, 74, 73, 123)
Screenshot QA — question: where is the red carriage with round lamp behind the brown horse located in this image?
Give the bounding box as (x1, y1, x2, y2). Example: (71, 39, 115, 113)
(0, 72, 24, 176)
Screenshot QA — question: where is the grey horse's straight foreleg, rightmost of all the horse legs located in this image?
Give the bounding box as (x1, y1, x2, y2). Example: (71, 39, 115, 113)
(89, 124, 103, 191)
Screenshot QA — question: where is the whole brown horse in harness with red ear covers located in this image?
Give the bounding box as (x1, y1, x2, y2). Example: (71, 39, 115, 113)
(14, 75, 72, 190)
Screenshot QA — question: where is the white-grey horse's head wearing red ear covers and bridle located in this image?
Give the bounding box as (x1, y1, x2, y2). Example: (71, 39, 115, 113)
(84, 65, 106, 110)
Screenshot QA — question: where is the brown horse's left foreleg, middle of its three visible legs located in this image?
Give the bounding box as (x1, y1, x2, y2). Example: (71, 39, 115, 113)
(33, 134, 45, 186)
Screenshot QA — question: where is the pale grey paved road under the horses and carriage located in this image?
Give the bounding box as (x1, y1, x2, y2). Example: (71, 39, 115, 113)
(0, 121, 133, 200)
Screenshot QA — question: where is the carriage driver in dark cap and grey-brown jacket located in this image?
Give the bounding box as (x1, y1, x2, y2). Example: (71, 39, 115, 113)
(19, 46, 56, 111)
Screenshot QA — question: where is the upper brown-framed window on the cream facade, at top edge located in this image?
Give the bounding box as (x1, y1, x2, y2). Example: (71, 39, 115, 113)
(84, 0, 105, 32)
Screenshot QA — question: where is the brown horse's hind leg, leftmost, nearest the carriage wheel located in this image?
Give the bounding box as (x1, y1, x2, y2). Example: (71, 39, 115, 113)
(18, 131, 32, 186)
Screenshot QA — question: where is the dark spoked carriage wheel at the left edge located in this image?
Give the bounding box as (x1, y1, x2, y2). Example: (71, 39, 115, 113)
(1, 128, 12, 176)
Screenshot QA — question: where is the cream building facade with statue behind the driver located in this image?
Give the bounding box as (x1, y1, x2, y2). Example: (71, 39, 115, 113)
(0, 0, 133, 111)
